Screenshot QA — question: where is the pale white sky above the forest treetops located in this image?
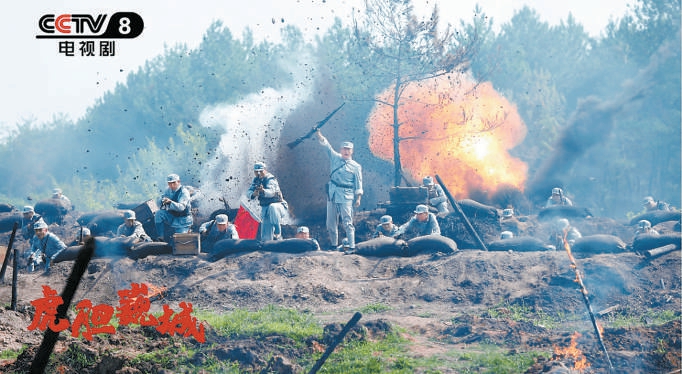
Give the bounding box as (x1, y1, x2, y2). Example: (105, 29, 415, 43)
(0, 0, 635, 139)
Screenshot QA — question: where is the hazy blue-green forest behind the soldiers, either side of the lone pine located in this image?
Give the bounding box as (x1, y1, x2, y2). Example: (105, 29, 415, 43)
(0, 0, 682, 217)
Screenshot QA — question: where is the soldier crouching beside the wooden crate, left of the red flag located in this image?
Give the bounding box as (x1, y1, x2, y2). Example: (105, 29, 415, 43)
(154, 174, 193, 242)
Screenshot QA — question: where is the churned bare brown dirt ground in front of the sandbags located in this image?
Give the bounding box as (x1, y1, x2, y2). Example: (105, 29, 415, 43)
(0, 210, 682, 373)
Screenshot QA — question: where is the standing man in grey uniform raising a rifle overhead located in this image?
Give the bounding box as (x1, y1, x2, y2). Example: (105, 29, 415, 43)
(315, 130, 363, 249)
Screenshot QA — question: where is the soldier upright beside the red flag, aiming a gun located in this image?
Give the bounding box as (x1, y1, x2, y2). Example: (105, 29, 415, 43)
(246, 162, 288, 241)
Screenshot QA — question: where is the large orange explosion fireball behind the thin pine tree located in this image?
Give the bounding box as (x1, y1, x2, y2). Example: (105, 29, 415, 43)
(368, 75, 527, 198)
